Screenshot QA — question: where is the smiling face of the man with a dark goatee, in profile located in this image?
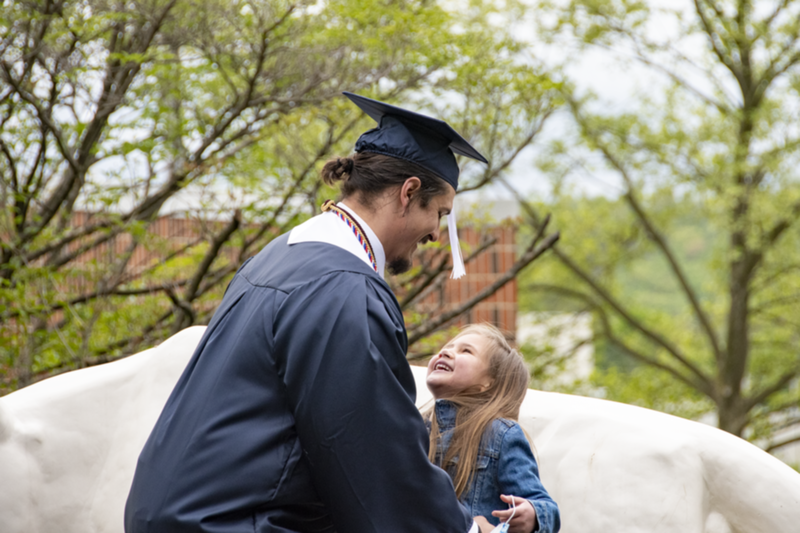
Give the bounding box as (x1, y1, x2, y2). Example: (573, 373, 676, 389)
(386, 187, 456, 274)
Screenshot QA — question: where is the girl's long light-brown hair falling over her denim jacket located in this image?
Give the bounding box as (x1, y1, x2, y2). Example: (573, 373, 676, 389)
(423, 324, 530, 498)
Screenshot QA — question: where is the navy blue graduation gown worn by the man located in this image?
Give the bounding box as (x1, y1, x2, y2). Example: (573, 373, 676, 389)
(125, 235, 472, 533)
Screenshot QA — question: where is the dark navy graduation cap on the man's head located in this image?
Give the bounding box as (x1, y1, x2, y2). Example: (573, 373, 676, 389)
(344, 92, 488, 190)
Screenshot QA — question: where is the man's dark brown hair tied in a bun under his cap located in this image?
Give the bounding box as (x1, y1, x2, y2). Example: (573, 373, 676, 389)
(322, 152, 450, 207)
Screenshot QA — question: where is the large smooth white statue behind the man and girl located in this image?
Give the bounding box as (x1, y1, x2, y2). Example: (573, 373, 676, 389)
(0, 327, 800, 533)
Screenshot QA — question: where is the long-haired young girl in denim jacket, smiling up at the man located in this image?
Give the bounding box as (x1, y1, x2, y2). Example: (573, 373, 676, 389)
(423, 324, 561, 533)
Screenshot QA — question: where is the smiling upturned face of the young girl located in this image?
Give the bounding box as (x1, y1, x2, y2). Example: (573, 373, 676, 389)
(426, 333, 491, 400)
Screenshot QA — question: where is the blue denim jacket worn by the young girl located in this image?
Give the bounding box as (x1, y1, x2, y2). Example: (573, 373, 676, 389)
(435, 400, 561, 533)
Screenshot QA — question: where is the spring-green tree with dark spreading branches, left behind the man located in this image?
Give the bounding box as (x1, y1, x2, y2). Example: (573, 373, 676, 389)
(0, 0, 558, 390)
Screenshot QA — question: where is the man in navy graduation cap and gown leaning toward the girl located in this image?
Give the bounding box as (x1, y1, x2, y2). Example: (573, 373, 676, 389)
(125, 93, 486, 533)
